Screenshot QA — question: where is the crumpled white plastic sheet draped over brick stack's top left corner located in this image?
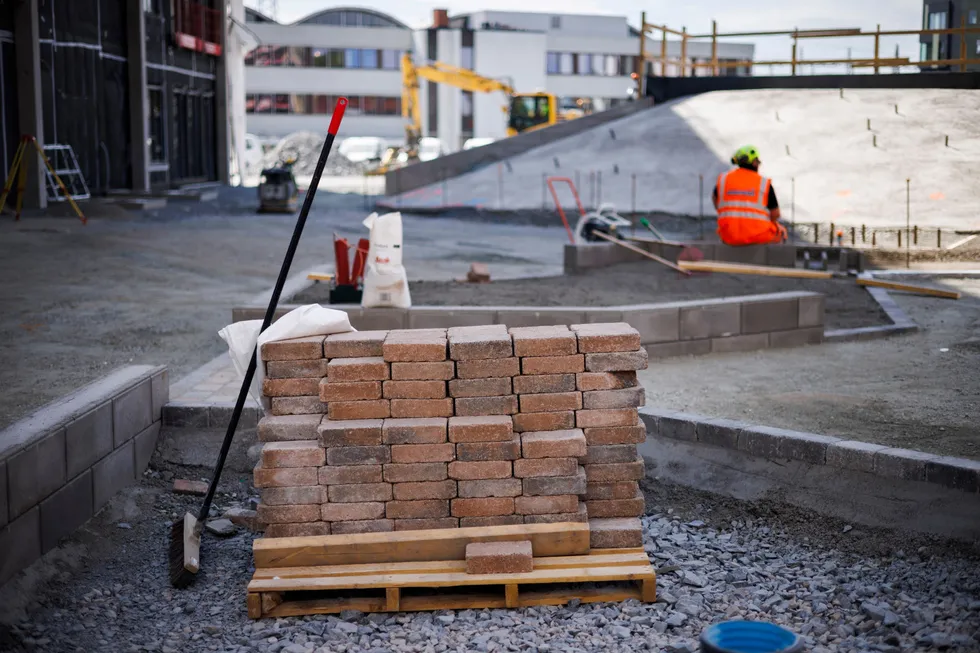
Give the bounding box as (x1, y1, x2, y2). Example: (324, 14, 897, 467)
(218, 304, 354, 410)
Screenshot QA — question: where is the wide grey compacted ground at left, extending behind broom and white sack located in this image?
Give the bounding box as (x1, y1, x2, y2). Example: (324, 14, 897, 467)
(0, 188, 565, 428)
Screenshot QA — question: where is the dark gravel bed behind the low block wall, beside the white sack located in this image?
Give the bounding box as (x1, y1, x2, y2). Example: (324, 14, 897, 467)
(296, 262, 890, 329)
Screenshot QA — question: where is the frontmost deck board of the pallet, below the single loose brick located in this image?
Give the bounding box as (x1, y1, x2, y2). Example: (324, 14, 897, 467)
(248, 563, 654, 592)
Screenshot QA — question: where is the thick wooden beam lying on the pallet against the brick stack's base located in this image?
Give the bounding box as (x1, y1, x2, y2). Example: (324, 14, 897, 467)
(252, 522, 589, 569)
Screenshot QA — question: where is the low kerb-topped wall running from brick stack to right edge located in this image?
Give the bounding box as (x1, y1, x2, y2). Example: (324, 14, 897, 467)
(640, 407, 980, 540)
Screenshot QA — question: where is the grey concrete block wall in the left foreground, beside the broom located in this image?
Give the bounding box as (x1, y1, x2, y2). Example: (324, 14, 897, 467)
(0, 365, 170, 584)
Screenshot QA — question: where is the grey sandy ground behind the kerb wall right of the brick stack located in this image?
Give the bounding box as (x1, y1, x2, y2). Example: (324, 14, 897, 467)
(641, 278, 980, 459)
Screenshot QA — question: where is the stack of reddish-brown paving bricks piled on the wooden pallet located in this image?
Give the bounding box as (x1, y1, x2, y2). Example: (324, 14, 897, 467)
(254, 323, 647, 548)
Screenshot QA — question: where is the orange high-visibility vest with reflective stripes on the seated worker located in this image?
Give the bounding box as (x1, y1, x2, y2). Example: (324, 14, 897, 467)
(718, 168, 780, 245)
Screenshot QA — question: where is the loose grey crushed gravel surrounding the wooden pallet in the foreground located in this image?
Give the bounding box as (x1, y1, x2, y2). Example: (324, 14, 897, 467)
(0, 448, 980, 653)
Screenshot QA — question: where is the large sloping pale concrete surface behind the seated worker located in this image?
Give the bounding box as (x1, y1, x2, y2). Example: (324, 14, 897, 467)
(389, 89, 980, 228)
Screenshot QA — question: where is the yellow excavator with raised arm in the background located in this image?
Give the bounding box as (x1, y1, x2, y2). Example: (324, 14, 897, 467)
(369, 52, 564, 175)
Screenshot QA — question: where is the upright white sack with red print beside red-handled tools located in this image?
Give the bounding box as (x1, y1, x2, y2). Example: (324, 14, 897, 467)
(361, 212, 412, 308)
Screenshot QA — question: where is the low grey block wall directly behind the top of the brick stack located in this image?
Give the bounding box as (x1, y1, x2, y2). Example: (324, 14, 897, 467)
(232, 292, 824, 358)
